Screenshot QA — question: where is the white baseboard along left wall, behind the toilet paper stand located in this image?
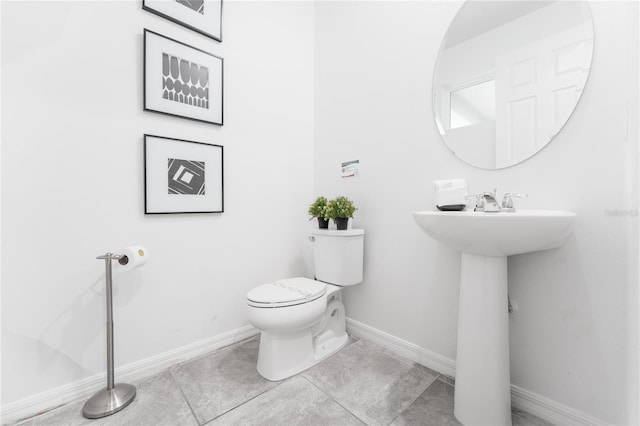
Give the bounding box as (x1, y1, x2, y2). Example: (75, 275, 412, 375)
(0, 325, 259, 425)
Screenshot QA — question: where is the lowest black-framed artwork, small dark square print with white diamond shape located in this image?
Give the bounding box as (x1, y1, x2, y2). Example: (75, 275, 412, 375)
(144, 135, 224, 214)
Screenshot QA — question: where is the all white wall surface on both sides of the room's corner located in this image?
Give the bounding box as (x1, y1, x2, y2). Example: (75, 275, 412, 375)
(0, 0, 638, 424)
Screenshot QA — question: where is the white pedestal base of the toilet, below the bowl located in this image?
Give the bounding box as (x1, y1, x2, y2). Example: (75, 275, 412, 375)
(257, 299, 349, 381)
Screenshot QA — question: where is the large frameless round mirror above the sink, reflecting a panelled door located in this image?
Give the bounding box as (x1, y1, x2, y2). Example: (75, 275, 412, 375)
(433, 0, 593, 169)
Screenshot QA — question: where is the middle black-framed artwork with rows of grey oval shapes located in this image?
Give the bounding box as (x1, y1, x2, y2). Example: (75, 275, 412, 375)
(143, 29, 223, 125)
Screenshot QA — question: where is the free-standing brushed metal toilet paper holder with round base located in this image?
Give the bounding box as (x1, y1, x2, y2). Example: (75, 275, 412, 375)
(82, 253, 136, 419)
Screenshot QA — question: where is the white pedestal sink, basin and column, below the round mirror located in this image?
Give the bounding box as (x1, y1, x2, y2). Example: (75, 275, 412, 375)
(413, 210, 576, 425)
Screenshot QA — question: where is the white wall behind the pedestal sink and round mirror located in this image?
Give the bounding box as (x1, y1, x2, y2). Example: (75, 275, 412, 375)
(315, 1, 638, 424)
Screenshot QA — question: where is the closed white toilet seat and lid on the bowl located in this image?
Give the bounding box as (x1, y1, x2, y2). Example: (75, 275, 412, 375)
(247, 277, 327, 308)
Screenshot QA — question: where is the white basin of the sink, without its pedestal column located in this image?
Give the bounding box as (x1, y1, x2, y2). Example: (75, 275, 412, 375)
(413, 210, 576, 256)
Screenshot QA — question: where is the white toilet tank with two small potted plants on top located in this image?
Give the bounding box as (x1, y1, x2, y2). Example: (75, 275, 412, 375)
(310, 229, 364, 286)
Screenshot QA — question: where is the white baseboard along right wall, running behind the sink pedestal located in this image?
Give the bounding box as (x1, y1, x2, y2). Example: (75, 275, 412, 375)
(347, 318, 608, 426)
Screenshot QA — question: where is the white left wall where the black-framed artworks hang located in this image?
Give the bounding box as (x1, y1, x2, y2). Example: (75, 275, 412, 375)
(1, 0, 314, 405)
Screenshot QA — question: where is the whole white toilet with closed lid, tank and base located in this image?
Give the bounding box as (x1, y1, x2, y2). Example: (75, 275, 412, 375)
(247, 229, 364, 381)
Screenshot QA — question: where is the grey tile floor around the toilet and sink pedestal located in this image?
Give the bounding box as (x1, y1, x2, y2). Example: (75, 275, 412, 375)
(19, 338, 550, 426)
